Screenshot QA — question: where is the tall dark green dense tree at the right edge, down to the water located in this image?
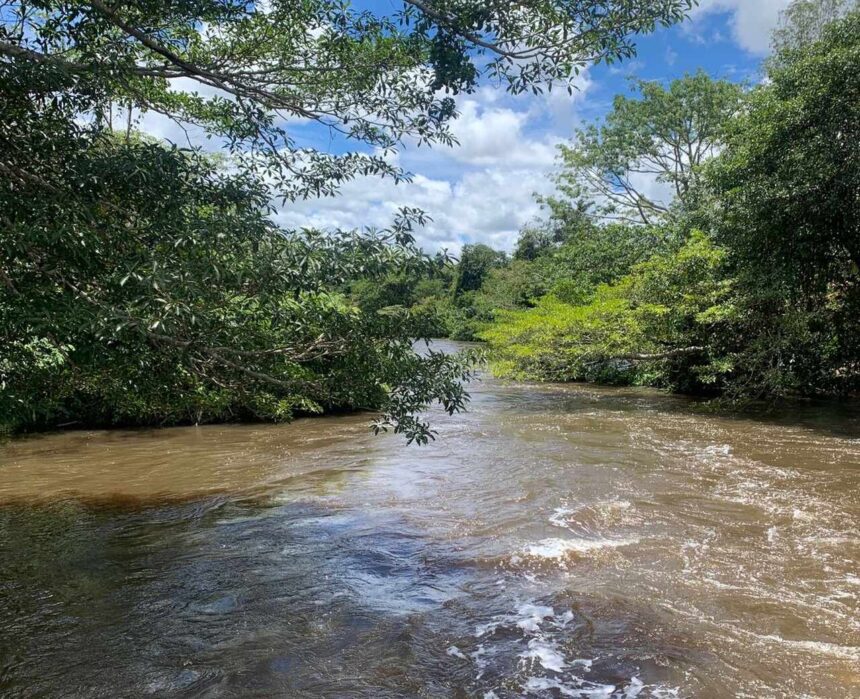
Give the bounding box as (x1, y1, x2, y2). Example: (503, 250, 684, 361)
(708, 11, 860, 395)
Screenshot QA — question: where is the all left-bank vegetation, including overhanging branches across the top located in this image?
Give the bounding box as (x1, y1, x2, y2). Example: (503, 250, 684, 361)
(0, 0, 691, 441)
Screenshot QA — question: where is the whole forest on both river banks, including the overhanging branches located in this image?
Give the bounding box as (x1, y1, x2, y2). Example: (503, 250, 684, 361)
(0, 0, 860, 442)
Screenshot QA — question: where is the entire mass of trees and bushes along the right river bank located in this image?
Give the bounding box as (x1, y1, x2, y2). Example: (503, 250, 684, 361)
(406, 0, 860, 400)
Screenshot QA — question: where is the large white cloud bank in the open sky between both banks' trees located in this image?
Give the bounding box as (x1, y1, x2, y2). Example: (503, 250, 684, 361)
(277, 73, 591, 253)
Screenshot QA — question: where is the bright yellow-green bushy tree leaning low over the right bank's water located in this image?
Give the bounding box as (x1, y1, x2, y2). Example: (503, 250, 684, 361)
(482, 231, 732, 390)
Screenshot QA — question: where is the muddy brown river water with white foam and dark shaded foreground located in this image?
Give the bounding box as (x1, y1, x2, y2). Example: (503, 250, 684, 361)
(0, 346, 860, 699)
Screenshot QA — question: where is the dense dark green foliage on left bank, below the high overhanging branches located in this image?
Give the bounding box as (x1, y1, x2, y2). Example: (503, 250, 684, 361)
(0, 131, 480, 440)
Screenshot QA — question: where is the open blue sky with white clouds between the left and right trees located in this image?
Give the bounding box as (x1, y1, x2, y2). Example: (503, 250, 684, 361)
(144, 0, 790, 254)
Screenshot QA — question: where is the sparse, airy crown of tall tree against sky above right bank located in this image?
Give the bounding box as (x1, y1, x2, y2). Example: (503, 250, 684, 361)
(556, 72, 743, 225)
